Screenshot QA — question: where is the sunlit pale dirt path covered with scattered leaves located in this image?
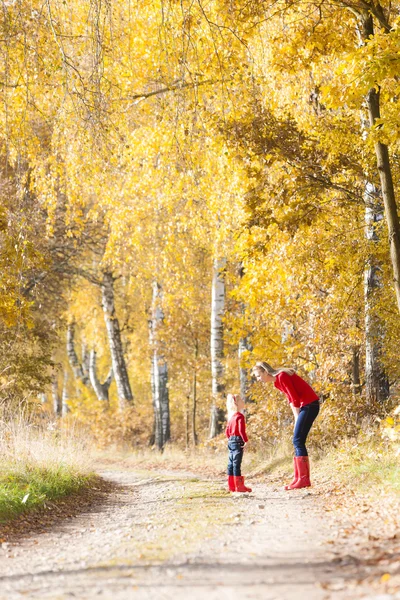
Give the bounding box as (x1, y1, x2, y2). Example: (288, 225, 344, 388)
(0, 470, 395, 600)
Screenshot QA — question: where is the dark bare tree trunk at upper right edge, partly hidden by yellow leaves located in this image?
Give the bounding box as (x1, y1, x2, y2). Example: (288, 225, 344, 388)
(362, 13, 400, 311)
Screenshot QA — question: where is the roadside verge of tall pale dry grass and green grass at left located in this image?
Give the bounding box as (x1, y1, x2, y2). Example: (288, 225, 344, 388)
(0, 419, 93, 523)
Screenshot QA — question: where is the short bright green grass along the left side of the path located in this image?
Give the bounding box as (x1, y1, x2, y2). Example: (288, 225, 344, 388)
(0, 466, 93, 523)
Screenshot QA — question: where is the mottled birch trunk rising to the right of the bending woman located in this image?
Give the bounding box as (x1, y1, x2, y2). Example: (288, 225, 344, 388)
(364, 183, 389, 403)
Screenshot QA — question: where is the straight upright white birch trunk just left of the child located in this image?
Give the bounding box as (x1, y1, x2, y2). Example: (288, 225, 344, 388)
(210, 258, 226, 439)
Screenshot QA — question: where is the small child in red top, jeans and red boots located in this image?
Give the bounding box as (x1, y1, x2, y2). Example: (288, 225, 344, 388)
(225, 394, 251, 492)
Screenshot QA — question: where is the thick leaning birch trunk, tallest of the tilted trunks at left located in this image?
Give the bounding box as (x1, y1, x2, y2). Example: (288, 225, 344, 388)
(101, 271, 133, 410)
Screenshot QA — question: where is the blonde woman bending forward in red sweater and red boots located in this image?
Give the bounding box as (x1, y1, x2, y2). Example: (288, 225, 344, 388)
(253, 362, 319, 490)
